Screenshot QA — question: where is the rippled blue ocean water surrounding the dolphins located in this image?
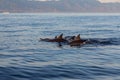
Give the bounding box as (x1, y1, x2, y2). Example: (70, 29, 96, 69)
(0, 14, 120, 80)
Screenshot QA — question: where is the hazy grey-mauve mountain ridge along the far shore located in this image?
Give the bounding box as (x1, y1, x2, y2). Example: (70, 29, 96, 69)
(0, 0, 120, 13)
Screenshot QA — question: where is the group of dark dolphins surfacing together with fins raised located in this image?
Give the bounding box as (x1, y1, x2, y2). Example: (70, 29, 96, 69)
(40, 33, 89, 46)
